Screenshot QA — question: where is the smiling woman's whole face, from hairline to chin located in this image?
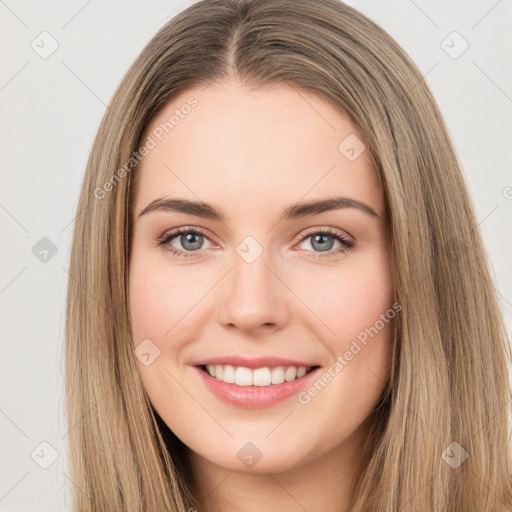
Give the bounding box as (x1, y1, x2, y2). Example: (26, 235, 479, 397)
(129, 82, 396, 472)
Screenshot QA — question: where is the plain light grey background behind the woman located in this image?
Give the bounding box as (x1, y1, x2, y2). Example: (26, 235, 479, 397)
(0, 0, 512, 512)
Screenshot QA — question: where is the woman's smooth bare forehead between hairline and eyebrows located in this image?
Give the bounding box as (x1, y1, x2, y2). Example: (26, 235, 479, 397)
(135, 82, 383, 220)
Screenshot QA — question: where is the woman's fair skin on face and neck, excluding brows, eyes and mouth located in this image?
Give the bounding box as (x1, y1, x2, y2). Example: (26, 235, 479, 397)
(129, 78, 393, 512)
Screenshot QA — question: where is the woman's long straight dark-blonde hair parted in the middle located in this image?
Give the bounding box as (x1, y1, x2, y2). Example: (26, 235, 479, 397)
(65, 0, 512, 512)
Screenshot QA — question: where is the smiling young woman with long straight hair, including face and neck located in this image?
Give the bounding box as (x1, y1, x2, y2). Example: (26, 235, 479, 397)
(66, 0, 512, 512)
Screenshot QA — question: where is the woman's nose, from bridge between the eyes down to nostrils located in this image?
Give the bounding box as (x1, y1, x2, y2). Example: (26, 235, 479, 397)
(214, 237, 289, 330)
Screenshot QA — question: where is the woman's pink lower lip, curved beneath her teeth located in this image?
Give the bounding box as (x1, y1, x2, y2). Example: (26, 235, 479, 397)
(194, 366, 320, 408)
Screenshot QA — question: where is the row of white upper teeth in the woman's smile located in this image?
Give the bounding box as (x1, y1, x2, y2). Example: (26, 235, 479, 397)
(206, 364, 310, 386)
